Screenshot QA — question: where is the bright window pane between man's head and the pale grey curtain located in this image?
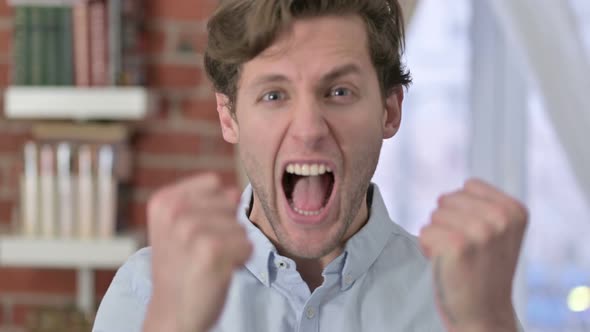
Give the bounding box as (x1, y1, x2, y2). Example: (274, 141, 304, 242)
(373, 0, 470, 234)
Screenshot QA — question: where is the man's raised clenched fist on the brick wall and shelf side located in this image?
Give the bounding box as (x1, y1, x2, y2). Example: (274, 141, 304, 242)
(144, 174, 252, 332)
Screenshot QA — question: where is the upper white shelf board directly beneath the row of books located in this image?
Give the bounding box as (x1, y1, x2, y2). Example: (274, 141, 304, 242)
(4, 86, 150, 120)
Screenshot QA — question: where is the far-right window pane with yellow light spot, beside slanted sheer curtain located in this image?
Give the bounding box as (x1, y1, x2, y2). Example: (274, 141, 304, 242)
(526, 0, 590, 332)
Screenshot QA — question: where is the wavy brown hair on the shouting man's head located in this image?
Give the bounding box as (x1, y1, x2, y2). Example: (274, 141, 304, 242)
(205, 0, 411, 111)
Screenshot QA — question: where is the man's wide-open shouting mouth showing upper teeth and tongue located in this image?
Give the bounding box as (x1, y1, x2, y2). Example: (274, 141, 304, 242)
(282, 163, 335, 217)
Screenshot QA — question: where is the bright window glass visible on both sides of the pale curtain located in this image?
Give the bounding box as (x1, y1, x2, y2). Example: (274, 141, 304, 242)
(373, 0, 590, 332)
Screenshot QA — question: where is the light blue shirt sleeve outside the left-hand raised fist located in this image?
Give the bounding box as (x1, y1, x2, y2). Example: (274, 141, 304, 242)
(92, 249, 151, 332)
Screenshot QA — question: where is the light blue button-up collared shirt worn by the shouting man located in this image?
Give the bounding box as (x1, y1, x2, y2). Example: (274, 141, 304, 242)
(93, 185, 444, 332)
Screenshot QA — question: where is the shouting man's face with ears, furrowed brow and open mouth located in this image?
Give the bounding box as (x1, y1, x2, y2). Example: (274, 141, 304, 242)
(217, 16, 403, 258)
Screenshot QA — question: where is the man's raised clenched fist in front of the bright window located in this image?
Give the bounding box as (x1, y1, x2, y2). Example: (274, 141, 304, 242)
(420, 180, 528, 332)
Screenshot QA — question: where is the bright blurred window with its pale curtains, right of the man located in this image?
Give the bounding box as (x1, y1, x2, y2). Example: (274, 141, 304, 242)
(374, 0, 590, 332)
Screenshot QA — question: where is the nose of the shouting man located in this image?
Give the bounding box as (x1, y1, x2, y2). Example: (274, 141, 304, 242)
(289, 98, 330, 149)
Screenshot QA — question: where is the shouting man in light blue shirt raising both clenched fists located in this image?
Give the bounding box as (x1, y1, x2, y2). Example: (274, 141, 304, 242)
(94, 0, 527, 332)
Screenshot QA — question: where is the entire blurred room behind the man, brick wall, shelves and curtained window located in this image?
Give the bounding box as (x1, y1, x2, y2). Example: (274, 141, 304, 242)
(0, 0, 590, 332)
